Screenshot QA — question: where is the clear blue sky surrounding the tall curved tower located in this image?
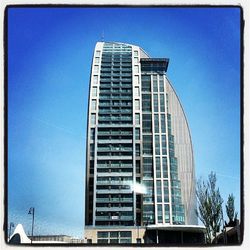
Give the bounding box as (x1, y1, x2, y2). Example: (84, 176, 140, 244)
(8, 8, 240, 237)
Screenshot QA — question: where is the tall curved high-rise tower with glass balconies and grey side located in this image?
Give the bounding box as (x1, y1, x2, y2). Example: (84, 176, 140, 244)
(85, 42, 197, 243)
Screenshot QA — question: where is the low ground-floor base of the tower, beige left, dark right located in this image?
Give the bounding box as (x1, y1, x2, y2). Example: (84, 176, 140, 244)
(84, 225, 206, 246)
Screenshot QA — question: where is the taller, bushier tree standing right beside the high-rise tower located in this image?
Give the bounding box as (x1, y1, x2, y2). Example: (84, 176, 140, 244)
(196, 172, 223, 243)
